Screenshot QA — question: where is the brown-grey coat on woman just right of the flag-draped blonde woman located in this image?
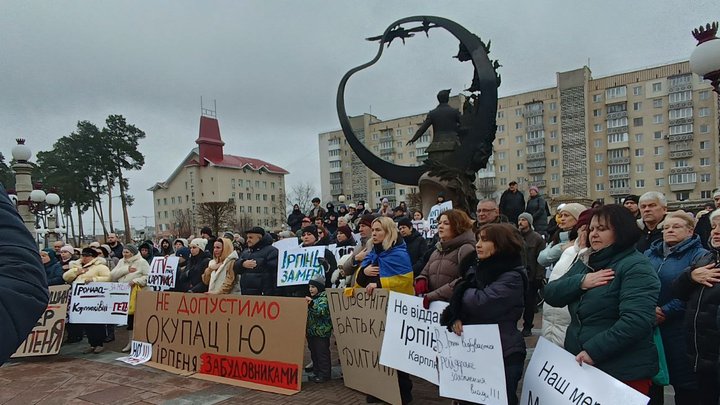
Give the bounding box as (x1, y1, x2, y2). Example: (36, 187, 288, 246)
(418, 231, 475, 301)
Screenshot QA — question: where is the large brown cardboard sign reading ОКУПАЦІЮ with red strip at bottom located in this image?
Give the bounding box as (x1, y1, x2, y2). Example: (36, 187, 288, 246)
(134, 291, 307, 395)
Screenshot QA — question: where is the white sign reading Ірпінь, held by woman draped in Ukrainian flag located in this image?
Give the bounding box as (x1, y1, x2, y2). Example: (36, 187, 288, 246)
(380, 291, 448, 385)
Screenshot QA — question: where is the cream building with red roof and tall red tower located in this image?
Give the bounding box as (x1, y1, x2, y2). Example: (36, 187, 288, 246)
(148, 115, 288, 237)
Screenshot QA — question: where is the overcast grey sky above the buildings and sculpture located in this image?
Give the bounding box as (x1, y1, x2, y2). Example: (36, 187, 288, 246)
(0, 0, 720, 230)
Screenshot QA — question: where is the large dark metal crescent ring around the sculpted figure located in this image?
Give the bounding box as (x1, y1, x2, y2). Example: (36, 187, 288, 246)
(336, 16, 500, 186)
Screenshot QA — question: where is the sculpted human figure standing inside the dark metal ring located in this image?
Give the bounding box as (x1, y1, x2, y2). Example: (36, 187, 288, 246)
(407, 89, 460, 161)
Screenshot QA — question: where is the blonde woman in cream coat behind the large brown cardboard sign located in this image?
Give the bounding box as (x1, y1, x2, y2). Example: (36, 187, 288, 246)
(202, 238, 240, 294)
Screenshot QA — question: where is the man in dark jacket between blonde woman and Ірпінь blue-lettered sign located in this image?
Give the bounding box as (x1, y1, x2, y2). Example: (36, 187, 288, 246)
(234, 226, 278, 295)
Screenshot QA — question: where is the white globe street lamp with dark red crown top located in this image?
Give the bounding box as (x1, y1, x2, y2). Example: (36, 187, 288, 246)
(690, 21, 720, 94)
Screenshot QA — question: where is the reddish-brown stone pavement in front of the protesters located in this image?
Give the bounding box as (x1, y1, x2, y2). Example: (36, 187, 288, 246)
(0, 314, 674, 405)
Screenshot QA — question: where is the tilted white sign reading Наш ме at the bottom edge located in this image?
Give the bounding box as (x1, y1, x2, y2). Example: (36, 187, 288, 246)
(520, 337, 649, 405)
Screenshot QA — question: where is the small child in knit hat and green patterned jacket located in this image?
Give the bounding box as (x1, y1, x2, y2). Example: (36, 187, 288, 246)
(305, 274, 332, 383)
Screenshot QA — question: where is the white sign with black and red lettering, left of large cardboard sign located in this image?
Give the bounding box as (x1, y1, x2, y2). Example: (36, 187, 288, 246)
(69, 282, 130, 325)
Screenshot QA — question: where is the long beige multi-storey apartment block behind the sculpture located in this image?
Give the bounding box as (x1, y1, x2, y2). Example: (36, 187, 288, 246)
(320, 62, 720, 207)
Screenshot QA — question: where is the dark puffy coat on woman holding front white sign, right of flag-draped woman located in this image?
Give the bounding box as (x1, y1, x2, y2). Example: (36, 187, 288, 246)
(440, 255, 528, 358)
